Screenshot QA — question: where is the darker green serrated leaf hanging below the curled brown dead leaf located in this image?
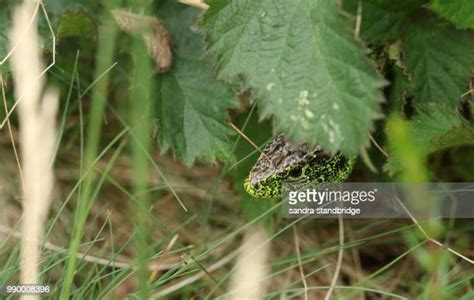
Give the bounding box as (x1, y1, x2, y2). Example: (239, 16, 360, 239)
(157, 1, 237, 165)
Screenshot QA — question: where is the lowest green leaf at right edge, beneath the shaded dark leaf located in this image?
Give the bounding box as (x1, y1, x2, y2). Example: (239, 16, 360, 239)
(384, 104, 474, 175)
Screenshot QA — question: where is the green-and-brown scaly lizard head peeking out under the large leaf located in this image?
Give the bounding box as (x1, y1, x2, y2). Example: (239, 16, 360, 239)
(244, 135, 355, 198)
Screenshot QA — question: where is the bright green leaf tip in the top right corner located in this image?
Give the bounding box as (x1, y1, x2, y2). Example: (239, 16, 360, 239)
(428, 0, 474, 29)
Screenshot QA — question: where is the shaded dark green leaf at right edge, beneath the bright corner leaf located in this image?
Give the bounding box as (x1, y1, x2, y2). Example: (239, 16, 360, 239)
(403, 18, 474, 107)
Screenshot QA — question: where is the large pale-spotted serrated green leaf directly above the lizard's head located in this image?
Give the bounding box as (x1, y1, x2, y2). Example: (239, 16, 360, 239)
(201, 0, 385, 154)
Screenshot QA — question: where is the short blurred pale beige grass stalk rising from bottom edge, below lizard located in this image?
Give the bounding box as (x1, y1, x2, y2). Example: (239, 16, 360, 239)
(230, 227, 270, 300)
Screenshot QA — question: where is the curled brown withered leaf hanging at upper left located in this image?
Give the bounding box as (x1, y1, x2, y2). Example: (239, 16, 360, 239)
(112, 9, 173, 73)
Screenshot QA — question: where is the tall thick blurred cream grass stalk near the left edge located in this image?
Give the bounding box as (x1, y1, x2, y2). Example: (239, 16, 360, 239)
(10, 1, 59, 290)
